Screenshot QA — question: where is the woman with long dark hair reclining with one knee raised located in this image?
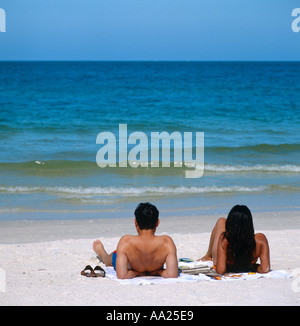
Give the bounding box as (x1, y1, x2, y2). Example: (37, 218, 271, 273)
(201, 205, 270, 274)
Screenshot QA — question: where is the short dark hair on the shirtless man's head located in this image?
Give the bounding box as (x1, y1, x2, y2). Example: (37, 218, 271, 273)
(134, 203, 159, 230)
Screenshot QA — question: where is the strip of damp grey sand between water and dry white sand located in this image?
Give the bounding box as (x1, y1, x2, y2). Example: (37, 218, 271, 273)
(0, 211, 300, 245)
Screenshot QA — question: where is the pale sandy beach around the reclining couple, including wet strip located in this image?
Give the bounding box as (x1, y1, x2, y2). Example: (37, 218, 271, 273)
(0, 212, 300, 306)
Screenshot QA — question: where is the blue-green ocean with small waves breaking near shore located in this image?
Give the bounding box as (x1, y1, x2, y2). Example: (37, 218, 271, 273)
(0, 62, 300, 220)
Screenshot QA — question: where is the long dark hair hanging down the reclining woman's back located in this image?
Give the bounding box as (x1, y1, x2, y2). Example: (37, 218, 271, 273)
(224, 205, 256, 272)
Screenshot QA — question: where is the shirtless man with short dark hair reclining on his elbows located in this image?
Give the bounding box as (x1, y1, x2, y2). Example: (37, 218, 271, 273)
(93, 203, 178, 279)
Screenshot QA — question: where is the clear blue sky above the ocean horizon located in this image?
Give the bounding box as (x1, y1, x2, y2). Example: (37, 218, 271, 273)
(0, 0, 300, 60)
